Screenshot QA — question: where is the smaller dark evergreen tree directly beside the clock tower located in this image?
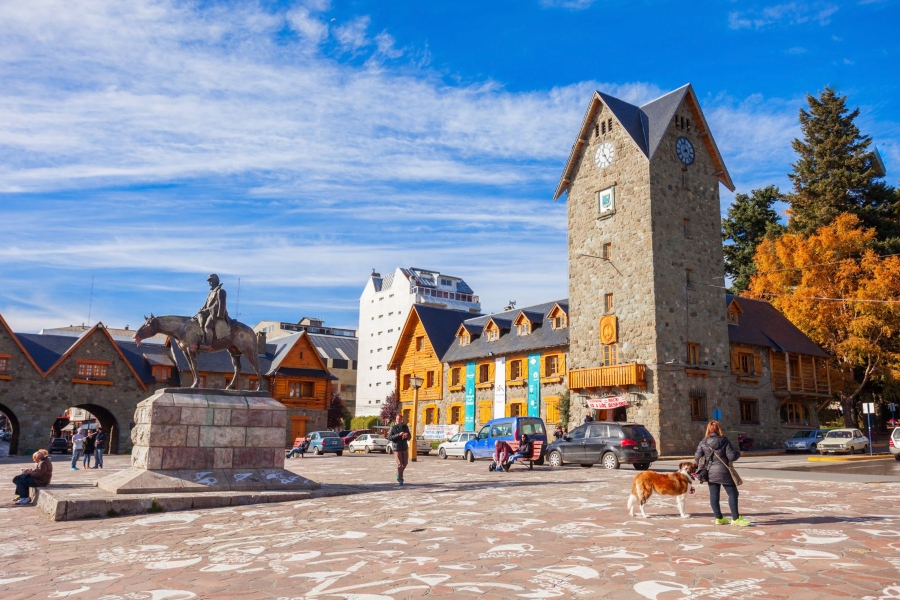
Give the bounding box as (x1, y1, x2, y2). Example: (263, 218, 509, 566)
(722, 185, 784, 292)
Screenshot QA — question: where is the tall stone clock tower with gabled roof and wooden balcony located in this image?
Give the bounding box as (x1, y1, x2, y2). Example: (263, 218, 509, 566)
(555, 85, 734, 453)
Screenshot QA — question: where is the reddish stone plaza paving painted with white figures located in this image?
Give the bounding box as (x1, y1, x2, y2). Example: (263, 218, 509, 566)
(0, 455, 900, 600)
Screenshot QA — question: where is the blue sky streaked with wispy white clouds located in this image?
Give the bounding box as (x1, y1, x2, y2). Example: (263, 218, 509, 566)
(0, 0, 900, 331)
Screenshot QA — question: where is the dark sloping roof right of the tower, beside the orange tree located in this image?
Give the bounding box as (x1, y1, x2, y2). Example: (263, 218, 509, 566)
(725, 294, 828, 357)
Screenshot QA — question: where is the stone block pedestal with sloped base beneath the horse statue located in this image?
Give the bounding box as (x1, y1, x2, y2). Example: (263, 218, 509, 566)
(97, 388, 319, 494)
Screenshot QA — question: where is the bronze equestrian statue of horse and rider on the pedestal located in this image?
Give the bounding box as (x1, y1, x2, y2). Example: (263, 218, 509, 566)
(134, 273, 263, 391)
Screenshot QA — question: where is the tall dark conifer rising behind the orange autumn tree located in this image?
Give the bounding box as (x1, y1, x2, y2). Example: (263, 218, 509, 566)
(788, 87, 900, 248)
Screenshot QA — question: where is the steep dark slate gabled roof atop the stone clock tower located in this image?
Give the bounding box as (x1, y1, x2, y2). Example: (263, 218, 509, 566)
(553, 83, 734, 200)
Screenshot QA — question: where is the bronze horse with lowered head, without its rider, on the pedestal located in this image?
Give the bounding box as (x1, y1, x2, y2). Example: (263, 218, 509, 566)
(134, 313, 263, 391)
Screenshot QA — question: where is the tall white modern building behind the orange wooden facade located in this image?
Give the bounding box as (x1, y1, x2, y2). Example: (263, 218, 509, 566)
(356, 267, 481, 416)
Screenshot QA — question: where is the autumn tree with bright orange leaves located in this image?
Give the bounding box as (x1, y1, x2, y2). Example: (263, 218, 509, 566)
(748, 214, 900, 427)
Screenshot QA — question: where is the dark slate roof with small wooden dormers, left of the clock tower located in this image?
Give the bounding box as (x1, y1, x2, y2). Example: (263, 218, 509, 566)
(441, 300, 569, 362)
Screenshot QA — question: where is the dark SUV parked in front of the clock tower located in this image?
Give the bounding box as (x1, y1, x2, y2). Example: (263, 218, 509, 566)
(547, 421, 659, 471)
